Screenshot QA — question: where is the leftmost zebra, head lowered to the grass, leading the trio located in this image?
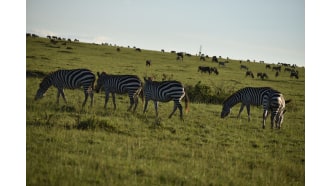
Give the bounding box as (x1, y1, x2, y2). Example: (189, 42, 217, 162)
(35, 69, 95, 106)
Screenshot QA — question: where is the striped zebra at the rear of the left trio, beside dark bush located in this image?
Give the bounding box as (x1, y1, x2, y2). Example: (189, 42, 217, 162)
(143, 78, 189, 120)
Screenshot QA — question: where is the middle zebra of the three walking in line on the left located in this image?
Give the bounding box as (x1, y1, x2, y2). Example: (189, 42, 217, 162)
(95, 72, 142, 112)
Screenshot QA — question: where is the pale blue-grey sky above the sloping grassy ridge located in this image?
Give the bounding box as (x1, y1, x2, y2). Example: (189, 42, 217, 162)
(26, 0, 305, 66)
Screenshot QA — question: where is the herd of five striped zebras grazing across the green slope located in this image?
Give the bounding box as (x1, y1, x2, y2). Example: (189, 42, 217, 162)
(35, 69, 289, 128)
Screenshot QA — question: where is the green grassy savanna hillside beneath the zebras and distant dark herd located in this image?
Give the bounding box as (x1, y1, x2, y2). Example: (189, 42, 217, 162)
(26, 38, 305, 185)
